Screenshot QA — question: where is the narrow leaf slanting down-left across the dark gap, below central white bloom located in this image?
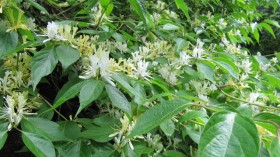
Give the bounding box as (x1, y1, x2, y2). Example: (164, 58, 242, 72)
(51, 81, 84, 109)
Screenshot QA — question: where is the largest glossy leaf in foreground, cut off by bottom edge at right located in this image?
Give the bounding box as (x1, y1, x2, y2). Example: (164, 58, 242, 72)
(198, 112, 260, 157)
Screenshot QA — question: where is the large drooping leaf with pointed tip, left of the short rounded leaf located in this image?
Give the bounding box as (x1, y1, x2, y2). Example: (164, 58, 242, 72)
(31, 47, 58, 90)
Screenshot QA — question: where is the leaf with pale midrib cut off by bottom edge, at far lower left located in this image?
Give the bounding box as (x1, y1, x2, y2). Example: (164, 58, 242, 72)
(22, 131, 55, 157)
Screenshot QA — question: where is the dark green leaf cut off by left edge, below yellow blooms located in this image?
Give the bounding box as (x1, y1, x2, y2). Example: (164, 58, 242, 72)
(0, 29, 18, 56)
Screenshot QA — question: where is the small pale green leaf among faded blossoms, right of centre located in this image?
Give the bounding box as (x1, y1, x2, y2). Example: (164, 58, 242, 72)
(196, 62, 215, 82)
